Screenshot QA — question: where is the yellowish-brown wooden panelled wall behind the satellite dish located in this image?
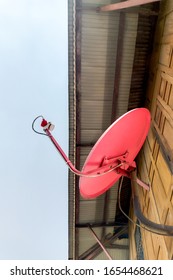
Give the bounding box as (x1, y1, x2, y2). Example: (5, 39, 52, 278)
(130, 0, 173, 260)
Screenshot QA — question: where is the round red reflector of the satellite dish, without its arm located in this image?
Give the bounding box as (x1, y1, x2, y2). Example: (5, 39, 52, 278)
(79, 108, 151, 198)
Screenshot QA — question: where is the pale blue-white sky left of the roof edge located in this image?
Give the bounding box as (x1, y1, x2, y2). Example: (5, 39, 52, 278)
(0, 0, 68, 260)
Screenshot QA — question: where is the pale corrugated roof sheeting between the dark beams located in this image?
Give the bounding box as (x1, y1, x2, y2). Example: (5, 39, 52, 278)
(76, 4, 138, 258)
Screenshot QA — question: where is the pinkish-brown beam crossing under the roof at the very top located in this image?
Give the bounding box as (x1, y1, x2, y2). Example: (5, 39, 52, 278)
(97, 0, 160, 12)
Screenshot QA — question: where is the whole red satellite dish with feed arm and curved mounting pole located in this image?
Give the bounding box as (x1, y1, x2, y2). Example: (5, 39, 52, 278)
(32, 108, 173, 236)
